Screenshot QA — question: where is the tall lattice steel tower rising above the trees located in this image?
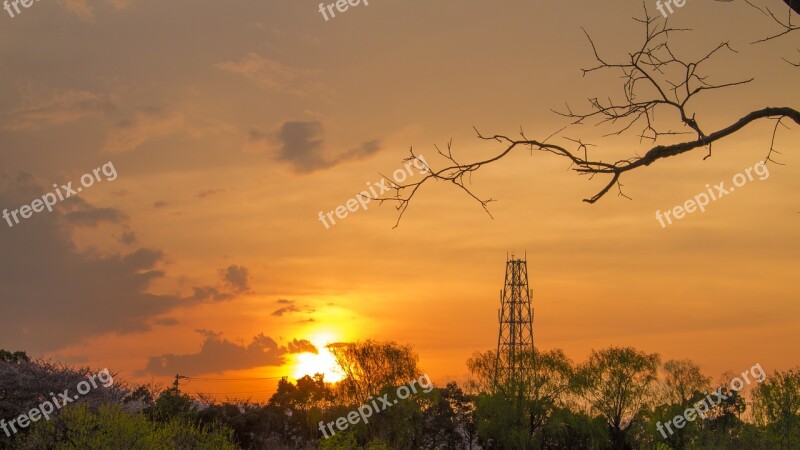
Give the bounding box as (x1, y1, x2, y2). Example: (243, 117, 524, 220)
(494, 255, 533, 386)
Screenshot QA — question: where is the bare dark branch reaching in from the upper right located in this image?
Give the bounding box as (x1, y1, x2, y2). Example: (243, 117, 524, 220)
(380, 0, 800, 226)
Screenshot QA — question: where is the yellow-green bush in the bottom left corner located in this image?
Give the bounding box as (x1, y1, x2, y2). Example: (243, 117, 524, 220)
(18, 405, 237, 450)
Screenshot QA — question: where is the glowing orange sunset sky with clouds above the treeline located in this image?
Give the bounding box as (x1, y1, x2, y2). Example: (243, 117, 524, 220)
(0, 0, 800, 400)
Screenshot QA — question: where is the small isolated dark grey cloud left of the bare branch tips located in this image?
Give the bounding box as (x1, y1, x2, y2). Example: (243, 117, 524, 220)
(272, 121, 380, 173)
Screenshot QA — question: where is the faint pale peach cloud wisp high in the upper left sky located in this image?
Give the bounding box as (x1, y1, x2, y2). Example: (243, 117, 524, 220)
(215, 53, 314, 95)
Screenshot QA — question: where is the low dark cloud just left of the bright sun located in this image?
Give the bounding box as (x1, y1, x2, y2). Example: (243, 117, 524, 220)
(144, 330, 317, 376)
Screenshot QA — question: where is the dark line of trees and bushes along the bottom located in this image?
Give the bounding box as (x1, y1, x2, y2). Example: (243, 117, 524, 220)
(0, 341, 800, 450)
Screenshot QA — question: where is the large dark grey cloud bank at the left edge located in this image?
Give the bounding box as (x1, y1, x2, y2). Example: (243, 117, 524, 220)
(0, 173, 252, 354)
